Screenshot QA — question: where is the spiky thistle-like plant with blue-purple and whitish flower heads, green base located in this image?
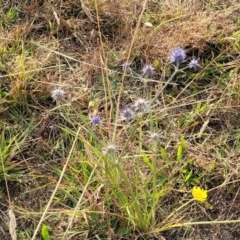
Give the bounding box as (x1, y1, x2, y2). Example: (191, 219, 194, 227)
(102, 47, 200, 232)
